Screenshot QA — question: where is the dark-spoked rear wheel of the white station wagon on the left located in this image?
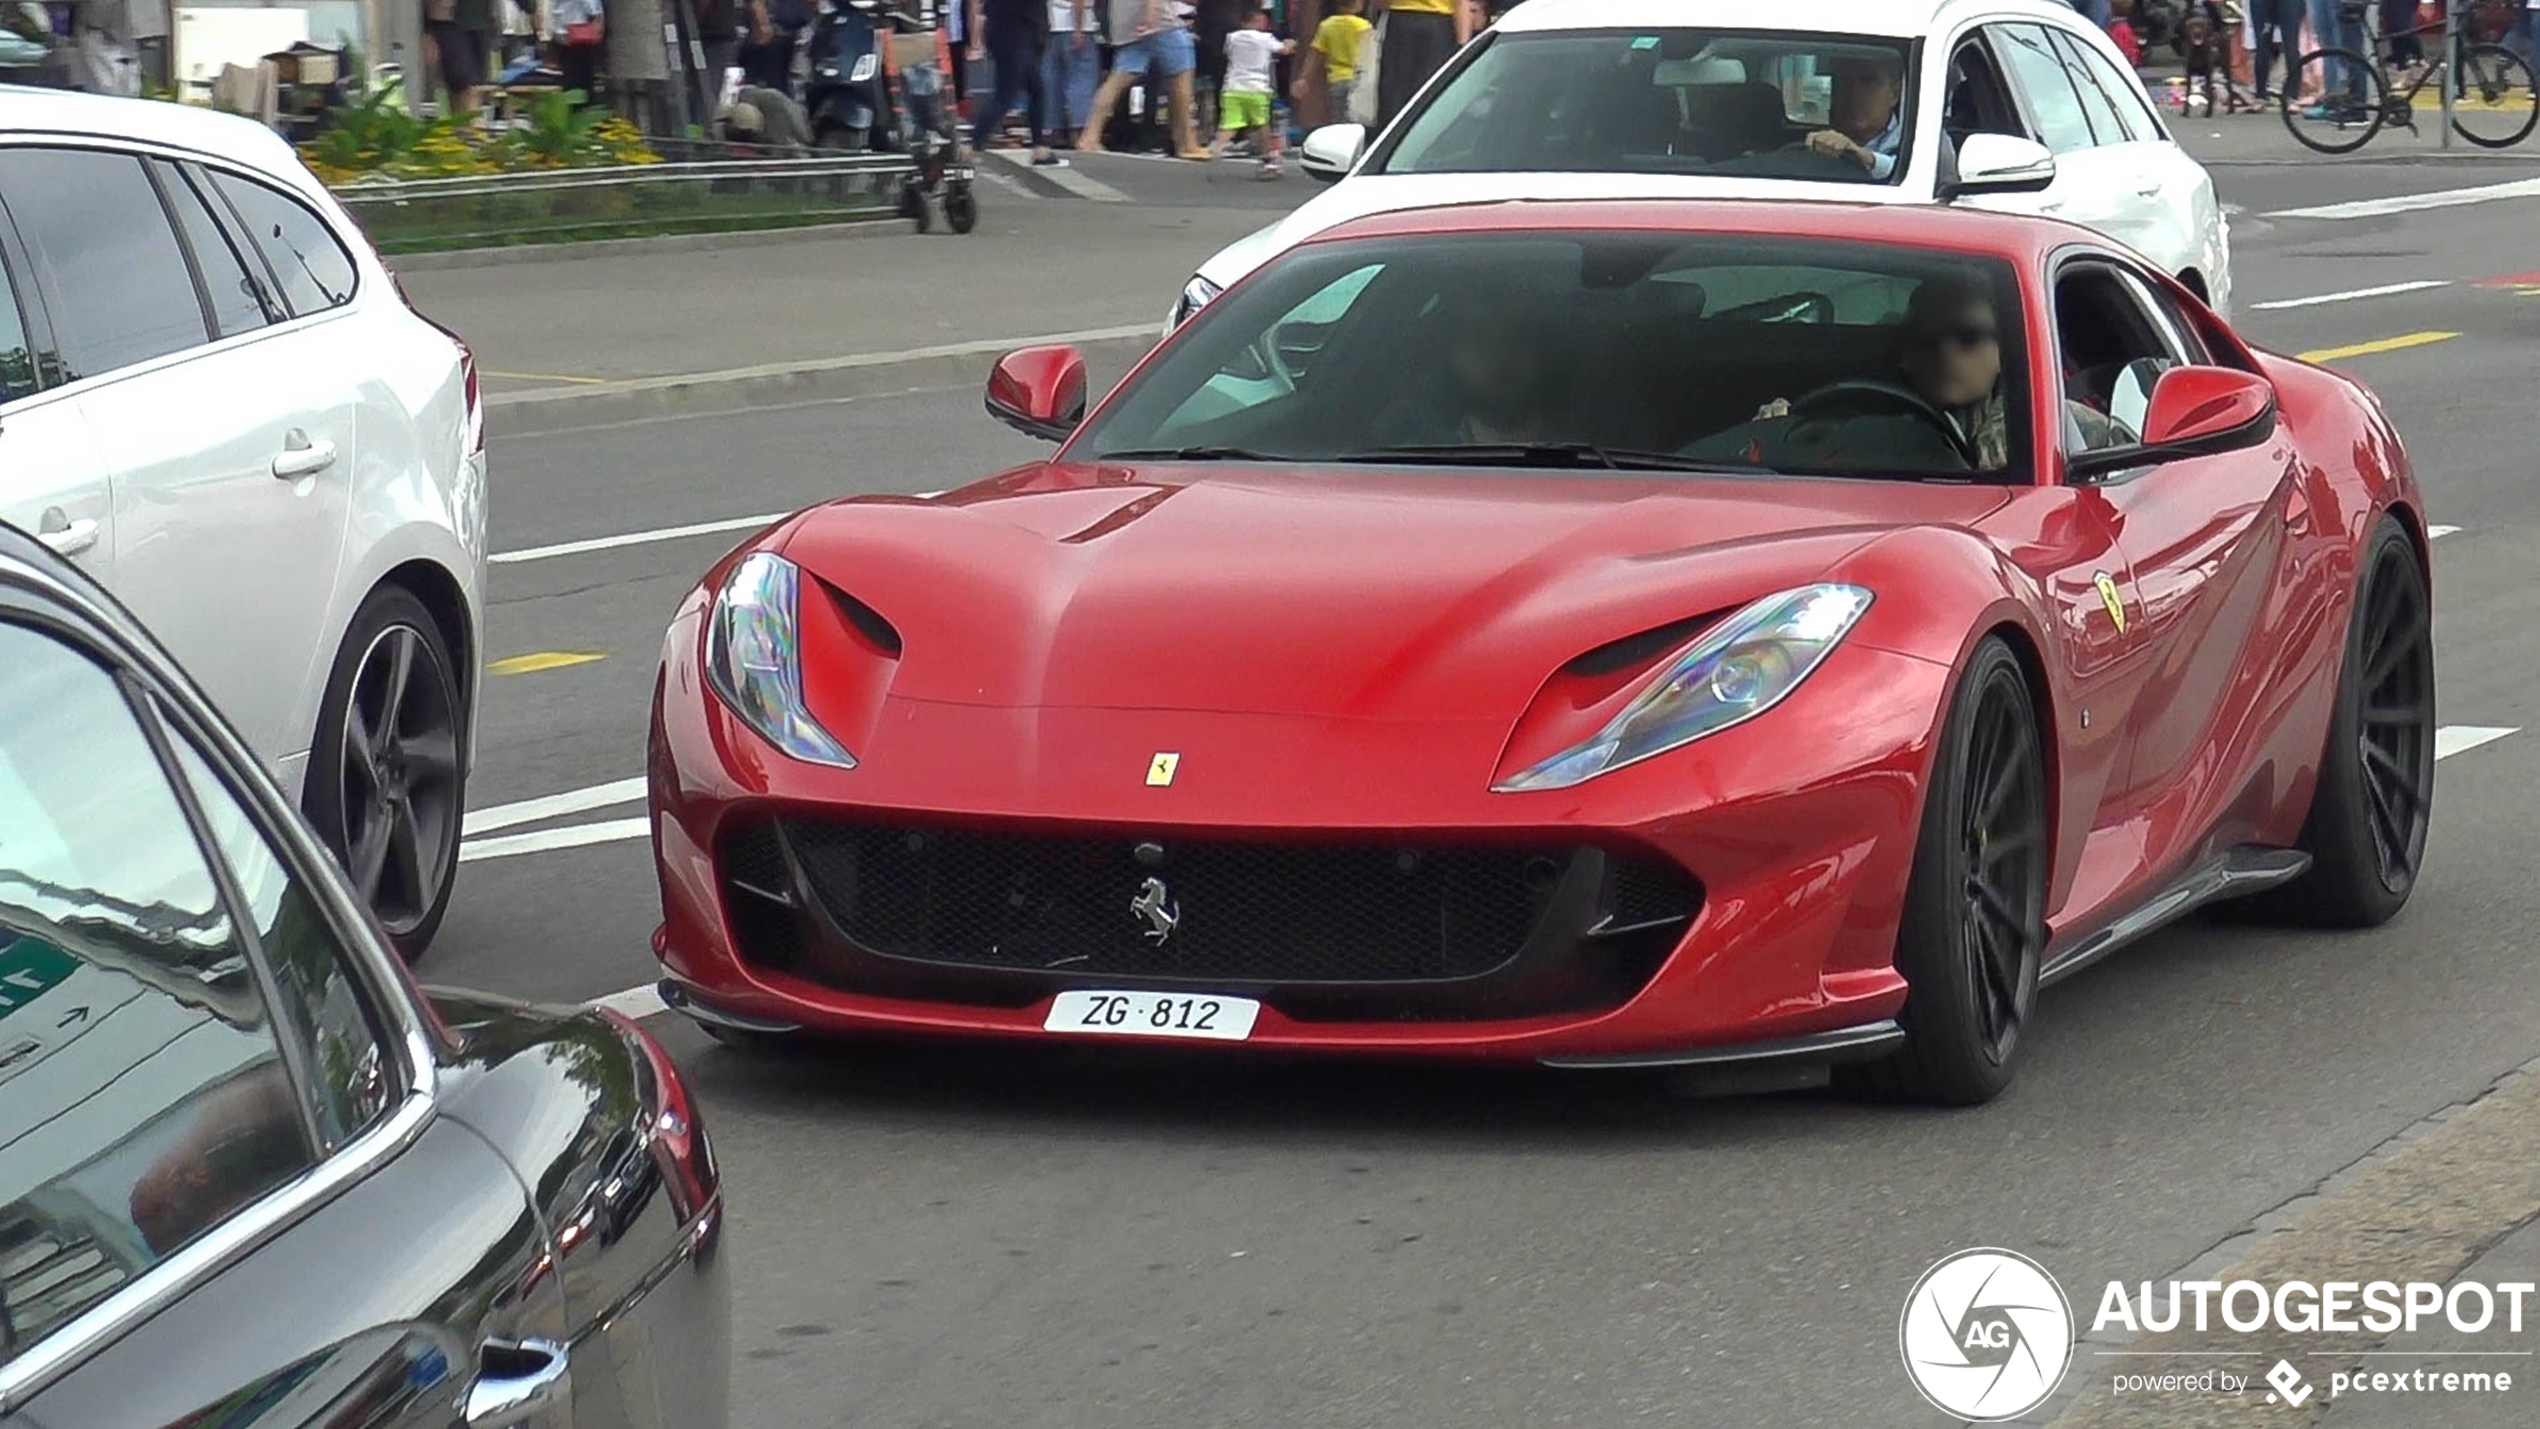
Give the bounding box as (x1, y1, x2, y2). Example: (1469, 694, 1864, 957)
(300, 586, 467, 962)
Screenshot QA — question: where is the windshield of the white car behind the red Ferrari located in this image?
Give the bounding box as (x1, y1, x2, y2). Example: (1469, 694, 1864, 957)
(1367, 30, 1913, 183)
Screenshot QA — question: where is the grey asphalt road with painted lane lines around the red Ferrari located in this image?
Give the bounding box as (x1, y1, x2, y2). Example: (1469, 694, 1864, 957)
(406, 148, 2540, 1429)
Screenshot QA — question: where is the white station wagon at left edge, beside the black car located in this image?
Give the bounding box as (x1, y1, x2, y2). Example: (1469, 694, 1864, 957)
(0, 89, 485, 957)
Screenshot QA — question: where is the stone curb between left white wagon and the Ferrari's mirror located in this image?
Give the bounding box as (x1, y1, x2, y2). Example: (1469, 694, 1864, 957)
(485, 322, 1161, 437)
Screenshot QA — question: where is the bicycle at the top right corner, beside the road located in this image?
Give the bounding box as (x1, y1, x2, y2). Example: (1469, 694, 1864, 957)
(2281, 0, 2540, 155)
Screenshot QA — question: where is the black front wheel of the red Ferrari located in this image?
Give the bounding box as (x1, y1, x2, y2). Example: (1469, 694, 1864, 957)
(1844, 637, 2047, 1107)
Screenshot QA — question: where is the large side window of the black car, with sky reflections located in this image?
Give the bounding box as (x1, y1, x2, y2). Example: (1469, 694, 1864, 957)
(0, 624, 315, 1363)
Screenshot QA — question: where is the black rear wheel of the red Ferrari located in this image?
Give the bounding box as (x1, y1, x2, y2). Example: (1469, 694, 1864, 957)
(2250, 518, 2436, 929)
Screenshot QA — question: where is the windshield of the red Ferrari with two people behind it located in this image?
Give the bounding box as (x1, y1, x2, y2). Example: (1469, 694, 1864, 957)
(1069, 231, 2027, 480)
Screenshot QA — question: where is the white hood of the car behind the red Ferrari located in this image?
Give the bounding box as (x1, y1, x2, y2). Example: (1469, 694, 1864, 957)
(1199, 173, 1928, 287)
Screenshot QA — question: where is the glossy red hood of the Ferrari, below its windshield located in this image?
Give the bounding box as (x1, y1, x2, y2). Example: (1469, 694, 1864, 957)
(782, 464, 2004, 723)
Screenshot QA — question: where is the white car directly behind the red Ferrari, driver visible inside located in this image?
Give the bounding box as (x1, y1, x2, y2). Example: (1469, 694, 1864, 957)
(1173, 0, 2230, 325)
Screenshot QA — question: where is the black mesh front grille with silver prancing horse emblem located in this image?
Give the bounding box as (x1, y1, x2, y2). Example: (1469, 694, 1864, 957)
(719, 820, 1699, 1018)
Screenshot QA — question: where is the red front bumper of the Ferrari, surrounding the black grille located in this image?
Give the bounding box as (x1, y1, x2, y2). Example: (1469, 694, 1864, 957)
(650, 614, 1948, 1066)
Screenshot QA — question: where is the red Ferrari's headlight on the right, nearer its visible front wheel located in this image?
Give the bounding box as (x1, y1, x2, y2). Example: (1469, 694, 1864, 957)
(1496, 586, 1869, 792)
